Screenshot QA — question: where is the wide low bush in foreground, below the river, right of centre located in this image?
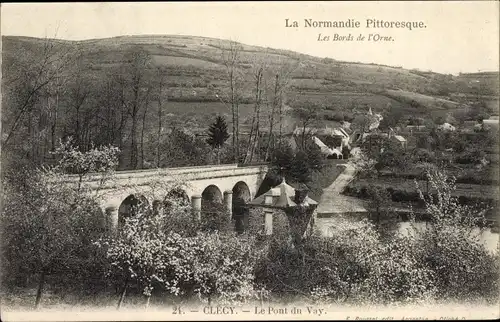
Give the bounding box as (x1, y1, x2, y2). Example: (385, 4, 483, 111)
(257, 222, 438, 305)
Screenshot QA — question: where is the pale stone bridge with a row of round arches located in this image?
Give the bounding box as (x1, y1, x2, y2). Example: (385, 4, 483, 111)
(61, 164, 268, 230)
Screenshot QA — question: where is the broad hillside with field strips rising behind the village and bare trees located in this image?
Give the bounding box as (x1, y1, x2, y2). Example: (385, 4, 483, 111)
(2, 35, 498, 170)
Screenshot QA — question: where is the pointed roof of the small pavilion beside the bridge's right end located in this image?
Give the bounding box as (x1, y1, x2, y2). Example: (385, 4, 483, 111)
(248, 178, 318, 208)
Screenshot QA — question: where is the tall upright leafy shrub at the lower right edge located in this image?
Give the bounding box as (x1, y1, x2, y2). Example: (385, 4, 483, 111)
(410, 169, 499, 300)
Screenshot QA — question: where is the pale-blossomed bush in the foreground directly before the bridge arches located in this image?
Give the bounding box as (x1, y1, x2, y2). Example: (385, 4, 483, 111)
(97, 197, 264, 302)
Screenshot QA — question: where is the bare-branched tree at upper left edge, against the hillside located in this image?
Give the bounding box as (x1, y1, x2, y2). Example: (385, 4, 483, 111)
(1, 38, 77, 168)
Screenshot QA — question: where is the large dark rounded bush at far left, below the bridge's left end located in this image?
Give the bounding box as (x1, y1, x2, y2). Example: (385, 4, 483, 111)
(1, 170, 110, 306)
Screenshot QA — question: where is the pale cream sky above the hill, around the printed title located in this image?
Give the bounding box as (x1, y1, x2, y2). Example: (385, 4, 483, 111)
(0, 1, 499, 74)
